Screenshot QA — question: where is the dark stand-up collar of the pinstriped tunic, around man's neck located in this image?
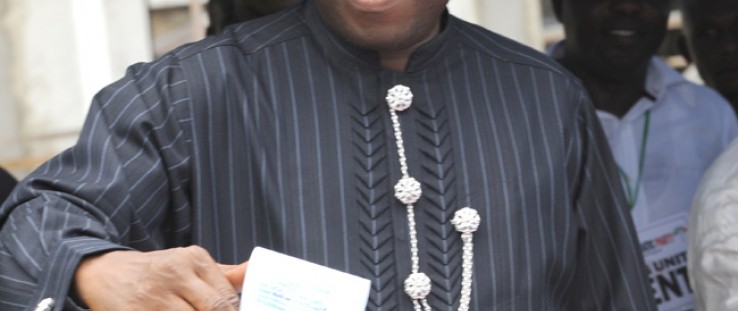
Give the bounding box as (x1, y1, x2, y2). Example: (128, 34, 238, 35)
(305, 0, 457, 73)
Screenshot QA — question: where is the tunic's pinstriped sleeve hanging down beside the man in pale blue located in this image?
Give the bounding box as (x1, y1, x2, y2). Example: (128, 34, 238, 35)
(567, 85, 656, 310)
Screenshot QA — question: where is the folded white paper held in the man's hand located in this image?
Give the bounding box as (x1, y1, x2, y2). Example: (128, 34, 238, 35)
(240, 247, 371, 311)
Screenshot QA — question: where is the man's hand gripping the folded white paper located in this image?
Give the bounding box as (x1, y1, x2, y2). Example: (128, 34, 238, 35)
(75, 246, 246, 311)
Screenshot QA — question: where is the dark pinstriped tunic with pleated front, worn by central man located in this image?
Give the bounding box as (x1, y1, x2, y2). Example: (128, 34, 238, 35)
(0, 1, 654, 311)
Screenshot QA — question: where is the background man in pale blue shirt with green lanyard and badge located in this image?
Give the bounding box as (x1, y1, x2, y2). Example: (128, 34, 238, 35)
(549, 0, 738, 310)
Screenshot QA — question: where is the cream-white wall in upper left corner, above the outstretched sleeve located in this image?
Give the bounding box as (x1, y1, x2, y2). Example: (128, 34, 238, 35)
(0, 0, 151, 175)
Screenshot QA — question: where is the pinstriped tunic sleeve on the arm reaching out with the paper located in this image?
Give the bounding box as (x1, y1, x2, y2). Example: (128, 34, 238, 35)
(0, 59, 193, 310)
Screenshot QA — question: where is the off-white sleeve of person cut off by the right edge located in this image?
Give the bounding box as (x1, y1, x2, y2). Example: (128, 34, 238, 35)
(687, 140, 738, 310)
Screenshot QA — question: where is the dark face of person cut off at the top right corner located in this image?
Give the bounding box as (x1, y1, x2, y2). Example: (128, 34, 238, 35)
(680, 0, 738, 111)
